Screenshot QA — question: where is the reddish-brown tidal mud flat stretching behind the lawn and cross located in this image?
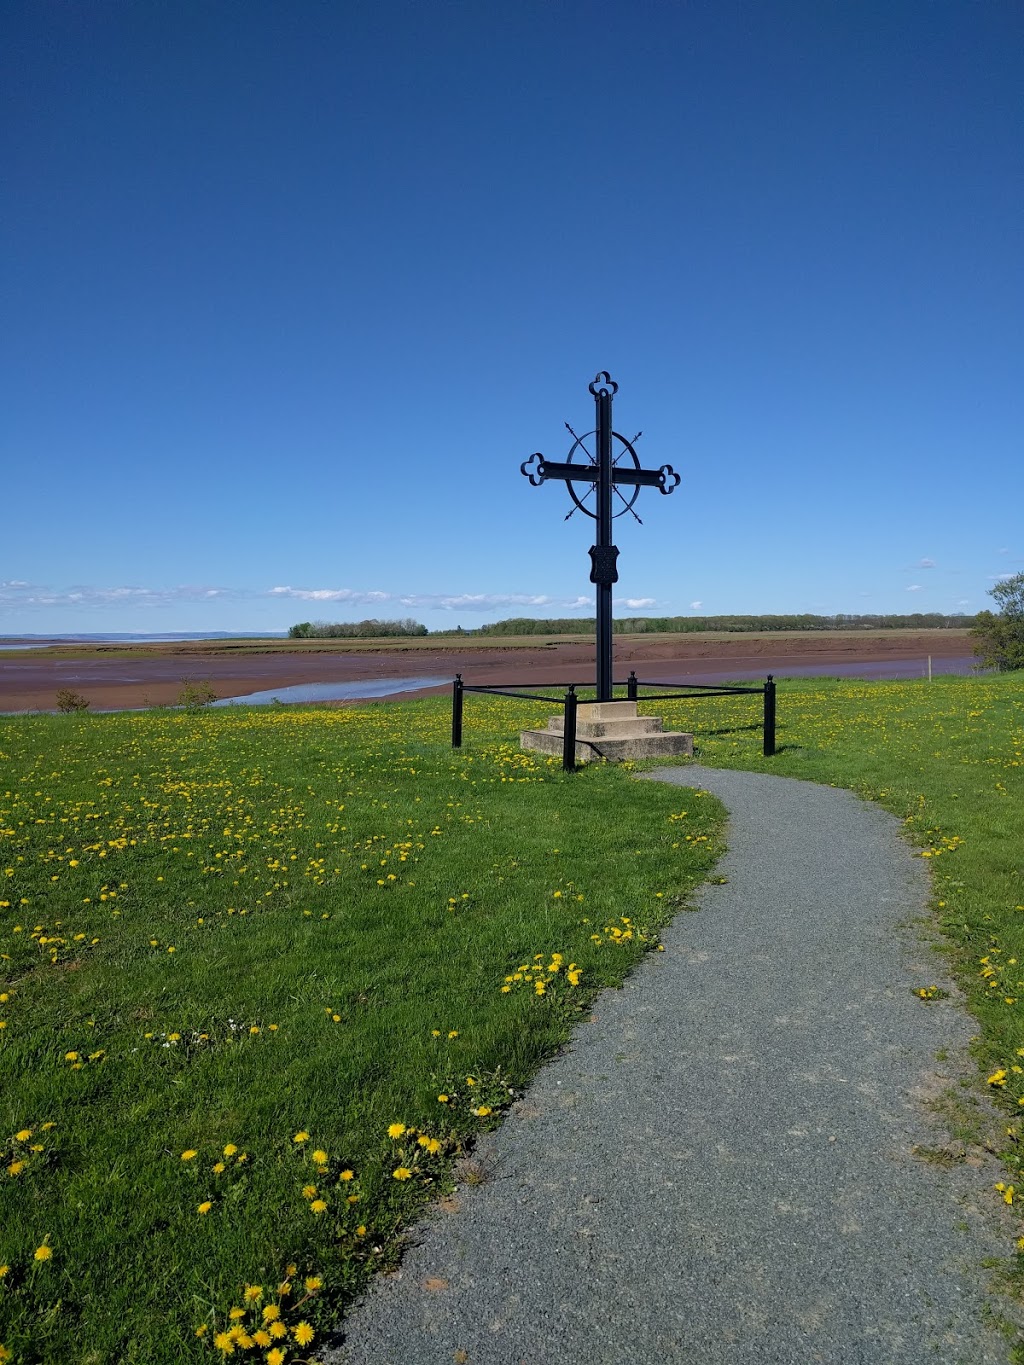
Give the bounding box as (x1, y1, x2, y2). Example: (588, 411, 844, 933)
(0, 631, 971, 713)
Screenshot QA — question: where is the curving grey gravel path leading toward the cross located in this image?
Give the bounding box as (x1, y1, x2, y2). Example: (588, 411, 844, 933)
(328, 767, 1012, 1365)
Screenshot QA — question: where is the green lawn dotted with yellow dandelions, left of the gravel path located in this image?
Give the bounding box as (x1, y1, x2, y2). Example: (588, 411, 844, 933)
(0, 698, 722, 1365)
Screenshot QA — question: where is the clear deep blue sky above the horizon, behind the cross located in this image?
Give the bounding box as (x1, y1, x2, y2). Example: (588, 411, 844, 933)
(0, 0, 1024, 633)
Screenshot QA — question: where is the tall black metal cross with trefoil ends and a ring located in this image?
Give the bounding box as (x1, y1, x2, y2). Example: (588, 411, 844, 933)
(520, 370, 679, 702)
